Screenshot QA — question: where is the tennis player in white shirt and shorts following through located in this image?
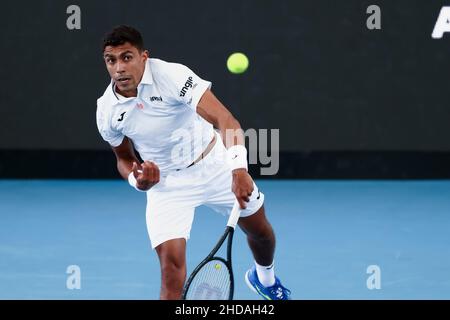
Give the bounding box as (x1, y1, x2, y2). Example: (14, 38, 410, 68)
(97, 25, 290, 300)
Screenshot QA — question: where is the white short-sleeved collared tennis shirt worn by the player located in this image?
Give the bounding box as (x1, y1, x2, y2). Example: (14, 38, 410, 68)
(97, 58, 214, 175)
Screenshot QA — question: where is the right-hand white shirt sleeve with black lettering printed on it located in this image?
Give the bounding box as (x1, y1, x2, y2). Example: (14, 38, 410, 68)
(163, 63, 212, 111)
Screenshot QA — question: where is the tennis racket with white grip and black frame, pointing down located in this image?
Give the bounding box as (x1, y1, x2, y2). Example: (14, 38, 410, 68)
(182, 201, 240, 300)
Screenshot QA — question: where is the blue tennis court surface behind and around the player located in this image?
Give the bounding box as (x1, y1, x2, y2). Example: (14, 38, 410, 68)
(0, 180, 450, 299)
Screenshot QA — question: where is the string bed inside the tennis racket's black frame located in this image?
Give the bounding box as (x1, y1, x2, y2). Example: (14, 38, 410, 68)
(186, 260, 231, 300)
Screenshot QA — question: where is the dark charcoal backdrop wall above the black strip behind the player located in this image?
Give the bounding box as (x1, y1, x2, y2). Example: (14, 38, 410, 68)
(0, 0, 450, 178)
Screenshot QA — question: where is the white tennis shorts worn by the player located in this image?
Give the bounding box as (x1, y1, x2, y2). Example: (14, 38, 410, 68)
(146, 132, 264, 249)
